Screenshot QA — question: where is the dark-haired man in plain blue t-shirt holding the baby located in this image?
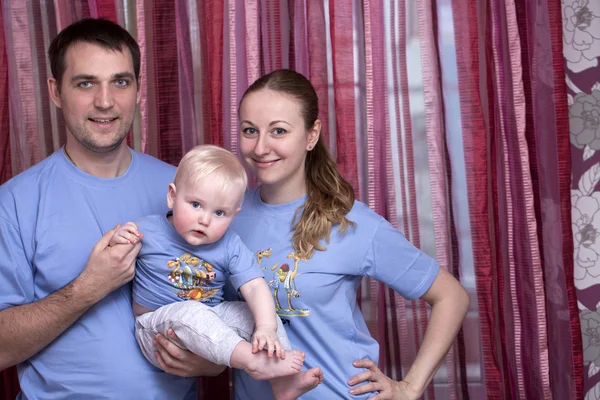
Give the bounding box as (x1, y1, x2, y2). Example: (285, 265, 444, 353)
(0, 19, 222, 400)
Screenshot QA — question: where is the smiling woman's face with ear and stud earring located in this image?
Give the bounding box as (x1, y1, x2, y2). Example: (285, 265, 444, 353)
(239, 89, 321, 192)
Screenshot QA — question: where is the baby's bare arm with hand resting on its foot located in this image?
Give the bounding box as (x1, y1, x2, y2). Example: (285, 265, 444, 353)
(240, 278, 285, 359)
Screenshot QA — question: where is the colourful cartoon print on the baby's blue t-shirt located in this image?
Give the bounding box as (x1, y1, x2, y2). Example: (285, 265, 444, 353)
(167, 253, 219, 301)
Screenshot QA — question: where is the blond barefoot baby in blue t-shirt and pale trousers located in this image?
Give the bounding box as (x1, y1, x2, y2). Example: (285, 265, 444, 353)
(110, 145, 323, 399)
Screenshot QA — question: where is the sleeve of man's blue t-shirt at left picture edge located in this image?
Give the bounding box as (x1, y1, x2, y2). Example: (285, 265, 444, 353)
(0, 217, 34, 310)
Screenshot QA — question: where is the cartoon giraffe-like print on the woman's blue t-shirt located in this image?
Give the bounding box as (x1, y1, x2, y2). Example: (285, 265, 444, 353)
(256, 248, 310, 317)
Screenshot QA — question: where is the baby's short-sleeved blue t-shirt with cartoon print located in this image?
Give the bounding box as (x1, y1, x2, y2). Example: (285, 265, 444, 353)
(133, 214, 263, 310)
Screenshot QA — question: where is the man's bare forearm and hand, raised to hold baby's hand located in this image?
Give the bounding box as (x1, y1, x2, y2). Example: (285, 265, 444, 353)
(0, 229, 141, 370)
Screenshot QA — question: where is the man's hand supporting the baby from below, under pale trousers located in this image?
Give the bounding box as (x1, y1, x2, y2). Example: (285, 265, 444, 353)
(154, 329, 225, 378)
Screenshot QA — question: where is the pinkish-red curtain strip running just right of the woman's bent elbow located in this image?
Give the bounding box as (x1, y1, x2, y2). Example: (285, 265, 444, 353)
(452, 0, 503, 399)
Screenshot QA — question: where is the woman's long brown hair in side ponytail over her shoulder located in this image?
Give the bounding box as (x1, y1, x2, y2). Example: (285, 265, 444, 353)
(240, 69, 355, 259)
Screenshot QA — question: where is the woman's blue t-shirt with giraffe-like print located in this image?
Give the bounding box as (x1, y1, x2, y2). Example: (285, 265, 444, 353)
(231, 189, 439, 400)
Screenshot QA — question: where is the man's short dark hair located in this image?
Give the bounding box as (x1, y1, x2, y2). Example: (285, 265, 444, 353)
(48, 18, 140, 88)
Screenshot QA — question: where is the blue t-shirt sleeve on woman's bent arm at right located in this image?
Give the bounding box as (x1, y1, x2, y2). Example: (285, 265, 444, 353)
(363, 218, 440, 300)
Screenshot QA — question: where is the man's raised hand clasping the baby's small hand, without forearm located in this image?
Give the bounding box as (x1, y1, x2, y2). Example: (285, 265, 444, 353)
(75, 224, 142, 303)
